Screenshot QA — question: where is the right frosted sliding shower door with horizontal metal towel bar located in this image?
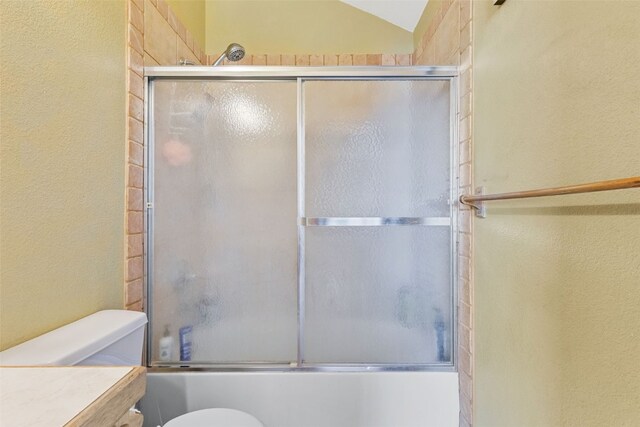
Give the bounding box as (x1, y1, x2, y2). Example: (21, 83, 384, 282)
(302, 80, 451, 364)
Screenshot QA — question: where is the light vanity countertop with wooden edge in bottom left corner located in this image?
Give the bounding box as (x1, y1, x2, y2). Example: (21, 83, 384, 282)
(0, 366, 146, 427)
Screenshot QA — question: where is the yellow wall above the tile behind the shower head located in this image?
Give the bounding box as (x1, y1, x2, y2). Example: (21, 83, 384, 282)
(206, 0, 413, 54)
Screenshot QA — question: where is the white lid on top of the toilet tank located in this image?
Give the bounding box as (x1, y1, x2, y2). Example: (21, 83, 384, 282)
(0, 310, 147, 366)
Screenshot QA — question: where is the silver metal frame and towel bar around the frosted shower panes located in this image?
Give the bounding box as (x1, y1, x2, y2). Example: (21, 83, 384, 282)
(144, 66, 459, 372)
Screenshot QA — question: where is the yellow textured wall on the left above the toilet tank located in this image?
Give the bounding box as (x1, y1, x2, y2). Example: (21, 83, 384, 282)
(0, 0, 127, 348)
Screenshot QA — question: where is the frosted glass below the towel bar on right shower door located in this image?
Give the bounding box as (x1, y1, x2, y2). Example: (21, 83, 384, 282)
(304, 226, 452, 364)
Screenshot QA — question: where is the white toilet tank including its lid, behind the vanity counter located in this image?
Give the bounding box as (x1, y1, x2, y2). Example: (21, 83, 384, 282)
(0, 310, 147, 366)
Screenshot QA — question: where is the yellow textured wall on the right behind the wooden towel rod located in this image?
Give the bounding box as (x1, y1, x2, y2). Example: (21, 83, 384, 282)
(473, 0, 640, 427)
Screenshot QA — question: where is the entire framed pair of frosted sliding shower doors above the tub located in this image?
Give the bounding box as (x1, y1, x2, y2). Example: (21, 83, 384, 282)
(145, 67, 457, 370)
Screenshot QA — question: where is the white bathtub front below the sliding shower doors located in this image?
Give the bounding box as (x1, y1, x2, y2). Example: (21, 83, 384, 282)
(140, 372, 459, 427)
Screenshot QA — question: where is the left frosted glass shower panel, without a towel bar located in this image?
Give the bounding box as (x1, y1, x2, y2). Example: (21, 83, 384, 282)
(152, 80, 297, 363)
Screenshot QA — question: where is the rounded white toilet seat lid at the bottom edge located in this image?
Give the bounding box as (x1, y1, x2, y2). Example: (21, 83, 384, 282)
(164, 408, 264, 427)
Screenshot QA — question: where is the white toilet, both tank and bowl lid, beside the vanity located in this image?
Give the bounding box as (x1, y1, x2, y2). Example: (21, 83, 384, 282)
(0, 310, 264, 427)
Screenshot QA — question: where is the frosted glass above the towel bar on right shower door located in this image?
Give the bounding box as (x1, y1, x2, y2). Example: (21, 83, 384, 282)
(304, 80, 451, 217)
